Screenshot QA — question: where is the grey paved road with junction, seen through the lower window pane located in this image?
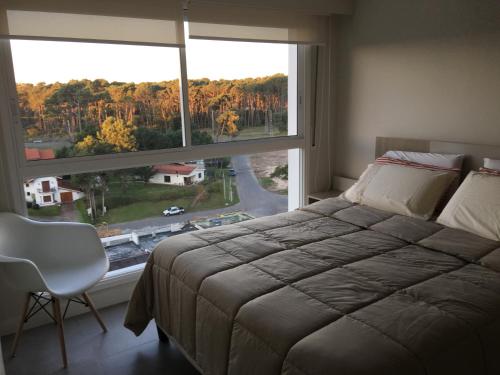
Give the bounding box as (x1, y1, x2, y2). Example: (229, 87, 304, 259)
(109, 155, 288, 232)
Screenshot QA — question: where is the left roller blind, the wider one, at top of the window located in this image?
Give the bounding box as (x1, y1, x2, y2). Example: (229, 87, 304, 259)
(0, 0, 184, 46)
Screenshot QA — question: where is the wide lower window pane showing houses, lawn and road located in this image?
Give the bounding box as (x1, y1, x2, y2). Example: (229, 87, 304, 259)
(23, 151, 288, 269)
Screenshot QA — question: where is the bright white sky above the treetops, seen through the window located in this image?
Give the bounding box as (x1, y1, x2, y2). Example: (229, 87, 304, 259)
(11, 39, 288, 83)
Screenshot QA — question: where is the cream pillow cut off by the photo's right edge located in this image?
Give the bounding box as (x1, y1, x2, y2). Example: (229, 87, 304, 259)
(437, 172, 500, 241)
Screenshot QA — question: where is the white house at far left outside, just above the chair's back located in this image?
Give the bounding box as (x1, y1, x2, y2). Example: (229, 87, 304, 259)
(24, 177, 85, 206)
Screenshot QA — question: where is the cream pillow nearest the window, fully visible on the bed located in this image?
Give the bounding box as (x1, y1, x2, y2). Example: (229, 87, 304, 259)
(341, 157, 457, 220)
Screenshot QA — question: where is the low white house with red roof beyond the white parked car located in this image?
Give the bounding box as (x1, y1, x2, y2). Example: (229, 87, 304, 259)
(149, 161, 205, 186)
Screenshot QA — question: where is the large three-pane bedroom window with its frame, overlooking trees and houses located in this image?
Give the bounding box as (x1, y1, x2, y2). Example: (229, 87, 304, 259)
(0, 4, 321, 269)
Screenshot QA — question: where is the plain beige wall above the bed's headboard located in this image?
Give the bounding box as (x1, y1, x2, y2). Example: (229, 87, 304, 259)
(333, 0, 500, 177)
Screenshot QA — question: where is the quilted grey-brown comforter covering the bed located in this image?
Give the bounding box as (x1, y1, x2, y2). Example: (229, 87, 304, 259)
(125, 198, 500, 375)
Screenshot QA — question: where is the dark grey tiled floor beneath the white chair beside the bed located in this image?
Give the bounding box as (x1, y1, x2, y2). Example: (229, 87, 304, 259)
(2, 304, 198, 375)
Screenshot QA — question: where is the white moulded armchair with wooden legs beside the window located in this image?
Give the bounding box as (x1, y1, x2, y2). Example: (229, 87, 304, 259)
(0, 213, 109, 367)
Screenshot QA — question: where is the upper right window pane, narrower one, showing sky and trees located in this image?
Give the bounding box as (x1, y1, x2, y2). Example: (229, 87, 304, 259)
(186, 39, 297, 145)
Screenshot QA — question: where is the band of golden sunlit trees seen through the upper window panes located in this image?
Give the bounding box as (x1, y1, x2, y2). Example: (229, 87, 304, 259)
(17, 74, 288, 157)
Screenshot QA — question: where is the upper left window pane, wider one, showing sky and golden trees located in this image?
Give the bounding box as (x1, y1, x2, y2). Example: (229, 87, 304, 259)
(11, 40, 182, 160)
